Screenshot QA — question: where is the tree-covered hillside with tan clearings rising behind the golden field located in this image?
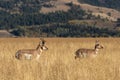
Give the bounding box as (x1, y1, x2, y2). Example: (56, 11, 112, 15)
(0, 0, 120, 37)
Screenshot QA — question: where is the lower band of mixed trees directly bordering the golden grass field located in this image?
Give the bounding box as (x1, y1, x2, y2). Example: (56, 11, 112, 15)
(11, 23, 120, 37)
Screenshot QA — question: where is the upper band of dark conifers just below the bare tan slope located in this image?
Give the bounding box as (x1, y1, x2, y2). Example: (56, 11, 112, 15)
(0, 5, 86, 29)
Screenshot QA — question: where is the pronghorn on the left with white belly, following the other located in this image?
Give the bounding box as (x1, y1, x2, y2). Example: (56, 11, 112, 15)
(15, 39, 48, 60)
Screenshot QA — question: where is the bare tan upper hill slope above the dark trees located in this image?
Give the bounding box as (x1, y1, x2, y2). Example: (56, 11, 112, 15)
(40, 0, 120, 21)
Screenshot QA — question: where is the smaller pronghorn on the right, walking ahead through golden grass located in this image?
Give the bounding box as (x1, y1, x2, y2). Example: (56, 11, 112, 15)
(75, 40, 103, 59)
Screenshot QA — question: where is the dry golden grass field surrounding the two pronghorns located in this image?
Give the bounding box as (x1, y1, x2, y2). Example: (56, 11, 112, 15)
(0, 38, 120, 80)
